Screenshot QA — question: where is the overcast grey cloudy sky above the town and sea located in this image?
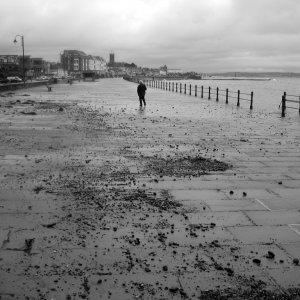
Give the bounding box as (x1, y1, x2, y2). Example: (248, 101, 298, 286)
(0, 0, 300, 72)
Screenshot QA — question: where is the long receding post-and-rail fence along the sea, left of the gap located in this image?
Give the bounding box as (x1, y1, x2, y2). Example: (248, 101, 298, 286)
(145, 80, 254, 109)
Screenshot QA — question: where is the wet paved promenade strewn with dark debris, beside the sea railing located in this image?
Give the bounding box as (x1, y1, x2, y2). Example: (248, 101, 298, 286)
(0, 79, 300, 300)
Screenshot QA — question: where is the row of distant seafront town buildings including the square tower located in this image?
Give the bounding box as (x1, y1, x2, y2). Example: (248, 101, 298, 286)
(0, 50, 190, 79)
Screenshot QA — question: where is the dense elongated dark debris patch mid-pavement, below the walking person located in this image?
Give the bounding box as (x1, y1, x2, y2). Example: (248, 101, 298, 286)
(144, 156, 230, 177)
